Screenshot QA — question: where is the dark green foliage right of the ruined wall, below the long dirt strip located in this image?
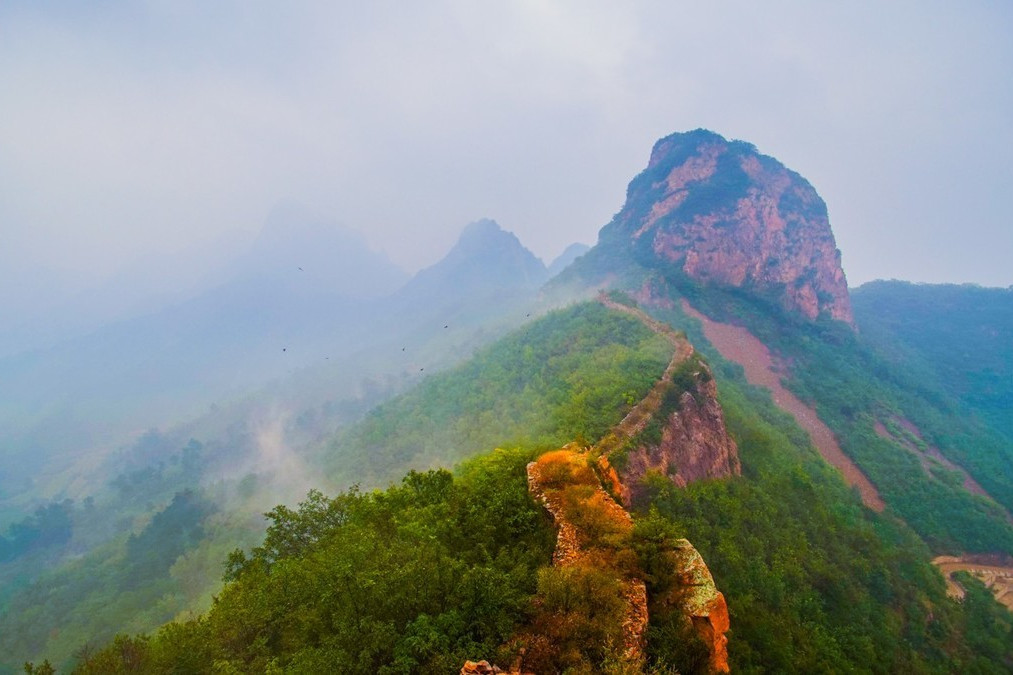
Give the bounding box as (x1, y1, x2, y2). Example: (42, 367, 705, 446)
(637, 364, 1013, 673)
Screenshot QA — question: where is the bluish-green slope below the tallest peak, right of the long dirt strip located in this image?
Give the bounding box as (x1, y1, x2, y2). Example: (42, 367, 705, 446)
(663, 277, 1013, 553)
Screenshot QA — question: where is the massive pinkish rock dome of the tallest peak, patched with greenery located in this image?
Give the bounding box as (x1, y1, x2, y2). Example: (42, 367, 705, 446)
(601, 130, 853, 323)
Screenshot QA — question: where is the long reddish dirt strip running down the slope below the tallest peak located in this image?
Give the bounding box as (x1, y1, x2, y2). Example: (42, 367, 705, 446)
(682, 299, 886, 512)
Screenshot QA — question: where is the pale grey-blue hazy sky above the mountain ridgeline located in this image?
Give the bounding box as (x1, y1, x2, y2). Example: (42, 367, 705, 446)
(0, 0, 1013, 292)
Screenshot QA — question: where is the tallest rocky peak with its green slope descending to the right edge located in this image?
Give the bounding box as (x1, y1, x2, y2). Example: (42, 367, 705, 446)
(550, 130, 1013, 553)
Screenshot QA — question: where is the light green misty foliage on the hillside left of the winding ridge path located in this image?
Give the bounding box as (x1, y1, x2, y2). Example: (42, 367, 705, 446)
(322, 303, 672, 484)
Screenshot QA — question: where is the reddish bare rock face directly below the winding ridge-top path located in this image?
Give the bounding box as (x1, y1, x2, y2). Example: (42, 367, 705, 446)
(621, 364, 742, 503)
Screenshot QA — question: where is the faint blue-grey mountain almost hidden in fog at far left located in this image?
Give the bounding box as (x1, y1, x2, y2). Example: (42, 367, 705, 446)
(0, 211, 403, 498)
